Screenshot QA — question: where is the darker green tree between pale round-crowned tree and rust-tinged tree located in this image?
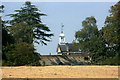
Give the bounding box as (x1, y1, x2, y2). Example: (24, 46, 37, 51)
(88, 30, 109, 64)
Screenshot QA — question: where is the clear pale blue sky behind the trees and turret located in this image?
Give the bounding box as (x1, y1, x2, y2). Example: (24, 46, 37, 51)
(2, 2, 116, 55)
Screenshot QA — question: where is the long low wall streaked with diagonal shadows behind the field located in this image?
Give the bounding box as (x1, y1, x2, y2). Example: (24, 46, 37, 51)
(40, 54, 89, 65)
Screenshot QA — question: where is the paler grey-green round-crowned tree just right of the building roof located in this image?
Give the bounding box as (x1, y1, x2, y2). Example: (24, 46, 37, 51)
(75, 16, 98, 51)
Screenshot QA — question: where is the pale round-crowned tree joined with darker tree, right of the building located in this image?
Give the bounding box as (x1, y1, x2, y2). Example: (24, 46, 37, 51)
(75, 16, 107, 64)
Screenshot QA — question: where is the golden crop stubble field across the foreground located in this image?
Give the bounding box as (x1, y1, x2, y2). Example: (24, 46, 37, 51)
(1, 66, 118, 78)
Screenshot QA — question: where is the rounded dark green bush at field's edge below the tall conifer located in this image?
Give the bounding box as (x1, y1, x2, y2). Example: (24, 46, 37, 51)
(3, 42, 40, 66)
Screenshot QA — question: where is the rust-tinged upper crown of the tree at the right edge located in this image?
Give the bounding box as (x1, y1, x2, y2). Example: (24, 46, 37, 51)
(103, 1, 120, 53)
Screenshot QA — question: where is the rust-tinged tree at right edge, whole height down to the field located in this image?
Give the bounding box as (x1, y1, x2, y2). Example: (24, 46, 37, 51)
(103, 1, 120, 64)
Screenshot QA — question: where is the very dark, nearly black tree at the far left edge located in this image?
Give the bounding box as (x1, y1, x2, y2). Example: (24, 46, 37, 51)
(0, 5, 14, 60)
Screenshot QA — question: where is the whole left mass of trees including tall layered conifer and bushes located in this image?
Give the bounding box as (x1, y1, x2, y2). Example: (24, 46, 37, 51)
(2, 1, 53, 66)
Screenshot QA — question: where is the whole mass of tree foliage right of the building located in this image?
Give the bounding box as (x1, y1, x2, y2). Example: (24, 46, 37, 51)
(75, 1, 120, 65)
